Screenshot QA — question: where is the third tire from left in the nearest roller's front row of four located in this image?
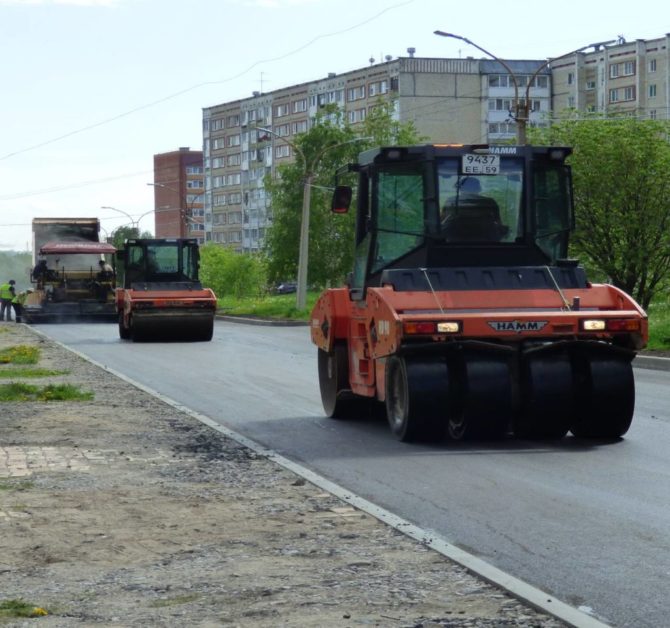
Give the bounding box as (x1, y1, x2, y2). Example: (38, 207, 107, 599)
(514, 351, 575, 440)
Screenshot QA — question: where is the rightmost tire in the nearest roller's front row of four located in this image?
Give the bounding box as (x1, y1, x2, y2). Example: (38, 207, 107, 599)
(570, 353, 635, 439)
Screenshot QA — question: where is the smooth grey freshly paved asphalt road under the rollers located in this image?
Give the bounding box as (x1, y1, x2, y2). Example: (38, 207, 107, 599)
(37, 321, 670, 628)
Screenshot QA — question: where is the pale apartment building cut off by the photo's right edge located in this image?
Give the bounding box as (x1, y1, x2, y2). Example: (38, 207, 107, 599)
(552, 34, 670, 120)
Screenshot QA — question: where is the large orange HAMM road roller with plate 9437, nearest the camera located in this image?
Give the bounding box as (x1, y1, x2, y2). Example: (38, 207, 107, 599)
(311, 145, 648, 441)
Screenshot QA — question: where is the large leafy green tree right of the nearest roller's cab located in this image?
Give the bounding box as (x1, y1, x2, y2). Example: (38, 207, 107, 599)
(533, 117, 670, 309)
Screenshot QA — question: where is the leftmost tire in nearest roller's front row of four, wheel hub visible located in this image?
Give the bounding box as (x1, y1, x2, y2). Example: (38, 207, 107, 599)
(386, 356, 450, 442)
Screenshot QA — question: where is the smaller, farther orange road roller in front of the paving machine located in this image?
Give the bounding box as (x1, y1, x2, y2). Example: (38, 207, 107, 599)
(116, 238, 217, 341)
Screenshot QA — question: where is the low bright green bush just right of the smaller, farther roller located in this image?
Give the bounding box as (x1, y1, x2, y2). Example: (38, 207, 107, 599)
(200, 244, 267, 299)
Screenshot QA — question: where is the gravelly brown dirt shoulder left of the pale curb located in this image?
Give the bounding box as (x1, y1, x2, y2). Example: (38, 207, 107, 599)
(0, 323, 563, 628)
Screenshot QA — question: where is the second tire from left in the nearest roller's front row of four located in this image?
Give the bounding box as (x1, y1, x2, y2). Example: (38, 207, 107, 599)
(447, 353, 513, 441)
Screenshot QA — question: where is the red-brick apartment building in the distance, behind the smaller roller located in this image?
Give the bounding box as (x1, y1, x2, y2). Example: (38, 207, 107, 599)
(150, 147, 205, 243)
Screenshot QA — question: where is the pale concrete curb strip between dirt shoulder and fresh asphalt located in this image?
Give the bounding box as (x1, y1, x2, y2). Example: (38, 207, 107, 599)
(31, 321, 616, 628)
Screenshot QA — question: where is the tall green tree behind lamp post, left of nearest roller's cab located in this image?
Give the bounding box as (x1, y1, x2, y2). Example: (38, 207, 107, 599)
(265, 100, 419, 286)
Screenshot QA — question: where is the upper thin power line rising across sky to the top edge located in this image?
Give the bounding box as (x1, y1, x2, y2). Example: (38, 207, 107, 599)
(0, 0, 416, 161)
